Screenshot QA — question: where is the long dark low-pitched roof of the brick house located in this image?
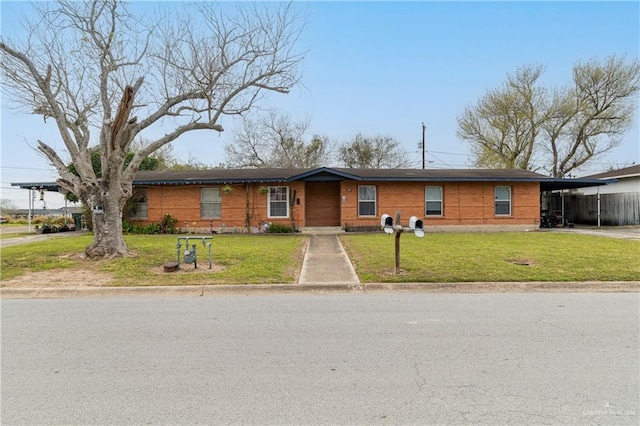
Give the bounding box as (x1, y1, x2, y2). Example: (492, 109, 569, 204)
(12, 167, 608, 191)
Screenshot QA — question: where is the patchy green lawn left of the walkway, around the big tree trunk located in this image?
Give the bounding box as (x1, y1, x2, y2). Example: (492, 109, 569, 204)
(1, 235, 306, 286)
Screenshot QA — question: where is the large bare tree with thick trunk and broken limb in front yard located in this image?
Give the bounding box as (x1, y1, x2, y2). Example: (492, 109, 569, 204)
(0, 0, 303, 258)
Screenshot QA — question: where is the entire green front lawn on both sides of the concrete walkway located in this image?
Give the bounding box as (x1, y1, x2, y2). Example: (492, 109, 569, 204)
(0, 232, 640, 286)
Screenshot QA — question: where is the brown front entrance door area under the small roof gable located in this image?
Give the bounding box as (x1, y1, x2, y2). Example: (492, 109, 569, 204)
(305, 181, 340, 226)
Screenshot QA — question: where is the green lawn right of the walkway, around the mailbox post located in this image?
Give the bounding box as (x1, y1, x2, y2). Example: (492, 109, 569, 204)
(340, 232, 640, 282)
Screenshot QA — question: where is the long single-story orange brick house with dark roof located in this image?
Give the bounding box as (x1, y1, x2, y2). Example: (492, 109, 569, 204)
(14, 167, 605, 232)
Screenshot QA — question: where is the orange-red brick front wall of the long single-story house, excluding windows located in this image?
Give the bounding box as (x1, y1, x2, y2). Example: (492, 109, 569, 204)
(136, 180, 540, 232)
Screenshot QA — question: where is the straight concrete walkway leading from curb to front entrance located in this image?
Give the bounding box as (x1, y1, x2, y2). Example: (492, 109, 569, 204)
(298, 234, 360, 285)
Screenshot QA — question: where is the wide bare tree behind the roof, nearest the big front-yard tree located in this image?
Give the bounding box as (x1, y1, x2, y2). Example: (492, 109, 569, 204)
(225, 112, 331, 168)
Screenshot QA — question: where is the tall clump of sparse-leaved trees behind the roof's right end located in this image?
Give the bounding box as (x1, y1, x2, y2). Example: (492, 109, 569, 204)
(458, 56, 640, 177)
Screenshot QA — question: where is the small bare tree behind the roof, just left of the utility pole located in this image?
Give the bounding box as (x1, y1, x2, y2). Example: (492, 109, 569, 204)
(338, 133, 409, 169)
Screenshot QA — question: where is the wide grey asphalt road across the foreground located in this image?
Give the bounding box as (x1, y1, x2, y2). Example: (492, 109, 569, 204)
(0, 293, 640, 425)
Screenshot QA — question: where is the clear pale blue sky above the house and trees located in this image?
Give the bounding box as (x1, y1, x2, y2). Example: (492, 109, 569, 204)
(1, 1, 640, 208)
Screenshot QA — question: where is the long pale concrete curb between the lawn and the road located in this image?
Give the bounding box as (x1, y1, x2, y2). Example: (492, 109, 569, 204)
(0, 281, 640, 299)
